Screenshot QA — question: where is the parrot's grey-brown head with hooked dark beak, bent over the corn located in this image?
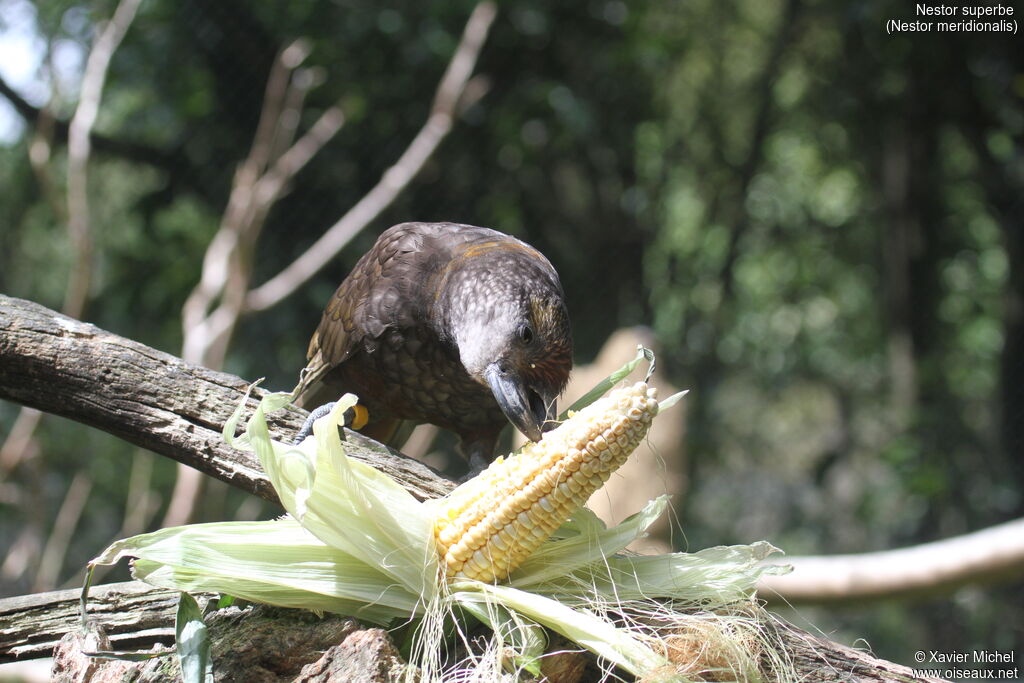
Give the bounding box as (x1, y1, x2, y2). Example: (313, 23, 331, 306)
(438, 243, 572, 441)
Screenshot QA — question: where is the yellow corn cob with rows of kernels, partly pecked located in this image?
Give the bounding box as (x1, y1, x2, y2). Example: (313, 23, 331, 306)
(434, 382, 657, 582)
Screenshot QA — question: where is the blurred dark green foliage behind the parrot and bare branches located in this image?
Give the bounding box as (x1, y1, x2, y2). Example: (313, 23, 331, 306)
(0, 0, 1024, 664)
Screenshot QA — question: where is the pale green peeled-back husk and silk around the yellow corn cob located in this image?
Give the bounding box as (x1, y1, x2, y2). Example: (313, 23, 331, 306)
(91, 355, 784, 681)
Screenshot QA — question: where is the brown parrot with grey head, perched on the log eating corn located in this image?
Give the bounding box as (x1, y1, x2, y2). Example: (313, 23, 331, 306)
(296, 223, 572, 471)
